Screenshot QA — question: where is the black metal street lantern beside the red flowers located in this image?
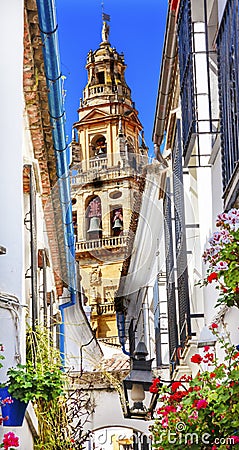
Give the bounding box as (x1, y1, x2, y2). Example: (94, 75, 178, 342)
(123, 342, 158, 420)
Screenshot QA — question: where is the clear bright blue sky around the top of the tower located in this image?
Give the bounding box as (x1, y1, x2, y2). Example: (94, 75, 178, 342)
(55, 0, 168, 155)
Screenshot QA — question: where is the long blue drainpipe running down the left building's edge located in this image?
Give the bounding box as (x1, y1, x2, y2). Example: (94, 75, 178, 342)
(36, 0, 76, 366)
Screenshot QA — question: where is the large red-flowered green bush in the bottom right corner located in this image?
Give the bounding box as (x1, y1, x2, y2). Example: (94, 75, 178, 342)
(151, 329, 239, 450)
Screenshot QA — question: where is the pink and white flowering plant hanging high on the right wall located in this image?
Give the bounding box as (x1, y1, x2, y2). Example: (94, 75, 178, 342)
(199, 208, 239, 308)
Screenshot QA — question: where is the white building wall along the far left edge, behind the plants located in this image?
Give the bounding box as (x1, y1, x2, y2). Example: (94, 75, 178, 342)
(0, 0, 35, 450)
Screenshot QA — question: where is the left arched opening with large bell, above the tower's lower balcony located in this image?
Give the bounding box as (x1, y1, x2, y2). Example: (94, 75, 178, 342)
(85, 196, 102, 239)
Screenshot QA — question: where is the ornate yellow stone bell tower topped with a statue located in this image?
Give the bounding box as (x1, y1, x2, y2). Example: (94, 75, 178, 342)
(71, 22, 147, 344)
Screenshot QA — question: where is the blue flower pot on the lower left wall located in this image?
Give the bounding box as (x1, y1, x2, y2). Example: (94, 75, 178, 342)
(0, 387, 27, 427)
